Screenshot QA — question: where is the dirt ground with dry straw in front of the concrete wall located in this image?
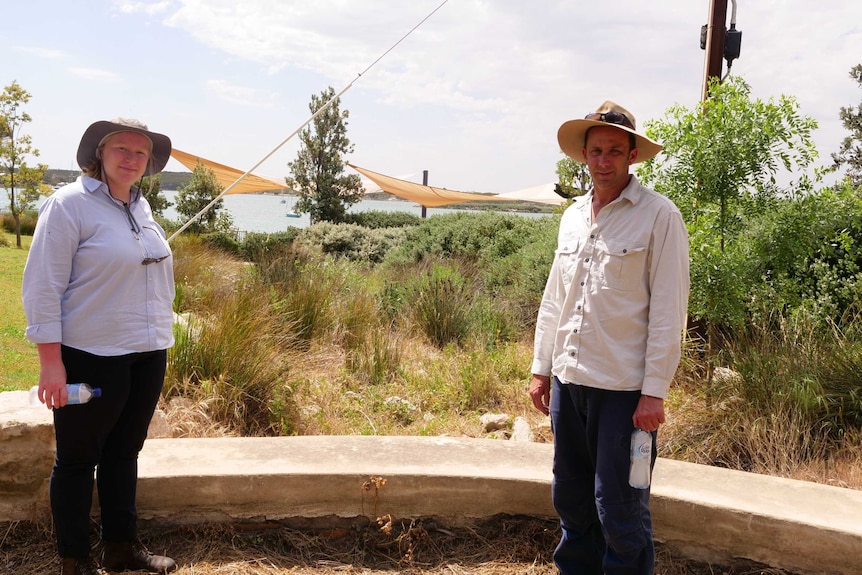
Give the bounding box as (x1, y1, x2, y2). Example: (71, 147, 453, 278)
(0, 517, 794, 575)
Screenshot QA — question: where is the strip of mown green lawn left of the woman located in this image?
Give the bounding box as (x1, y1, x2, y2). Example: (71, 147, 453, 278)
(0, 232, 39, 391)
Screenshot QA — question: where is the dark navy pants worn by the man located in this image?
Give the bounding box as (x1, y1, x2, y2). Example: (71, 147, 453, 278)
(550, 377, 655, 575)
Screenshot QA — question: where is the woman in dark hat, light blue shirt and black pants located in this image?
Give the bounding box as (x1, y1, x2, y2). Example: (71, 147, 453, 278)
(23, 118, 177, 575)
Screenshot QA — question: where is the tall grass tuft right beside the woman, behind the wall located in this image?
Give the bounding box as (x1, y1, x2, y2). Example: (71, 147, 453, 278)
(164, 237, 295, 435)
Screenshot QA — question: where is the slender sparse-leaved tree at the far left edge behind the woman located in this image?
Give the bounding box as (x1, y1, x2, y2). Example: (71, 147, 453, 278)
(0, 82, 51, 248)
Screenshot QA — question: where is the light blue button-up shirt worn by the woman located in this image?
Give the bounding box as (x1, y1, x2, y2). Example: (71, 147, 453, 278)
(23, 176, 174, 356)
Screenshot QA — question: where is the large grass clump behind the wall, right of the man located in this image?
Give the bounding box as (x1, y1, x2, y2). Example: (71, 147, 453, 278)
(667, 315, 862, 476)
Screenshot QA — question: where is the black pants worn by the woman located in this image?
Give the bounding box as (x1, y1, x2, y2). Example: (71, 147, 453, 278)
(50, 346, 167, 557)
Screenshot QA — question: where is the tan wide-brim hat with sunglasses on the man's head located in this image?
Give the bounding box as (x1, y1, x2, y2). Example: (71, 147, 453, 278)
(557, 100, 662, 163)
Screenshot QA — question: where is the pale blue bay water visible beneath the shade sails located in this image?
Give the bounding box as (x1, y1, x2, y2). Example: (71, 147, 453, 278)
(0, 190, 548, 234)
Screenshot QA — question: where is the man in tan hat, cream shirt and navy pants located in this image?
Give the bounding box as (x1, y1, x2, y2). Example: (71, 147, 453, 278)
(530, 101, 689, 575)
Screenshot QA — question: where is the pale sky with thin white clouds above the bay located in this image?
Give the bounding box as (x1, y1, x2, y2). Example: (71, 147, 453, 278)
(0, 0, 862, 193)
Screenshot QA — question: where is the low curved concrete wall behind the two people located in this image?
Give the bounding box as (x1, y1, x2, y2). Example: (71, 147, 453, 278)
(0, 392, 862, 575)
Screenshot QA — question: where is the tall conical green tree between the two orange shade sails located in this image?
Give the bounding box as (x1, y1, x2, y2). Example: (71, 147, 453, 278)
(287, 86, 362, 223)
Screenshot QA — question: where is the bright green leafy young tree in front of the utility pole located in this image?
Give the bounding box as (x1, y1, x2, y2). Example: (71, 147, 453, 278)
(638, 77, 817, 340)
